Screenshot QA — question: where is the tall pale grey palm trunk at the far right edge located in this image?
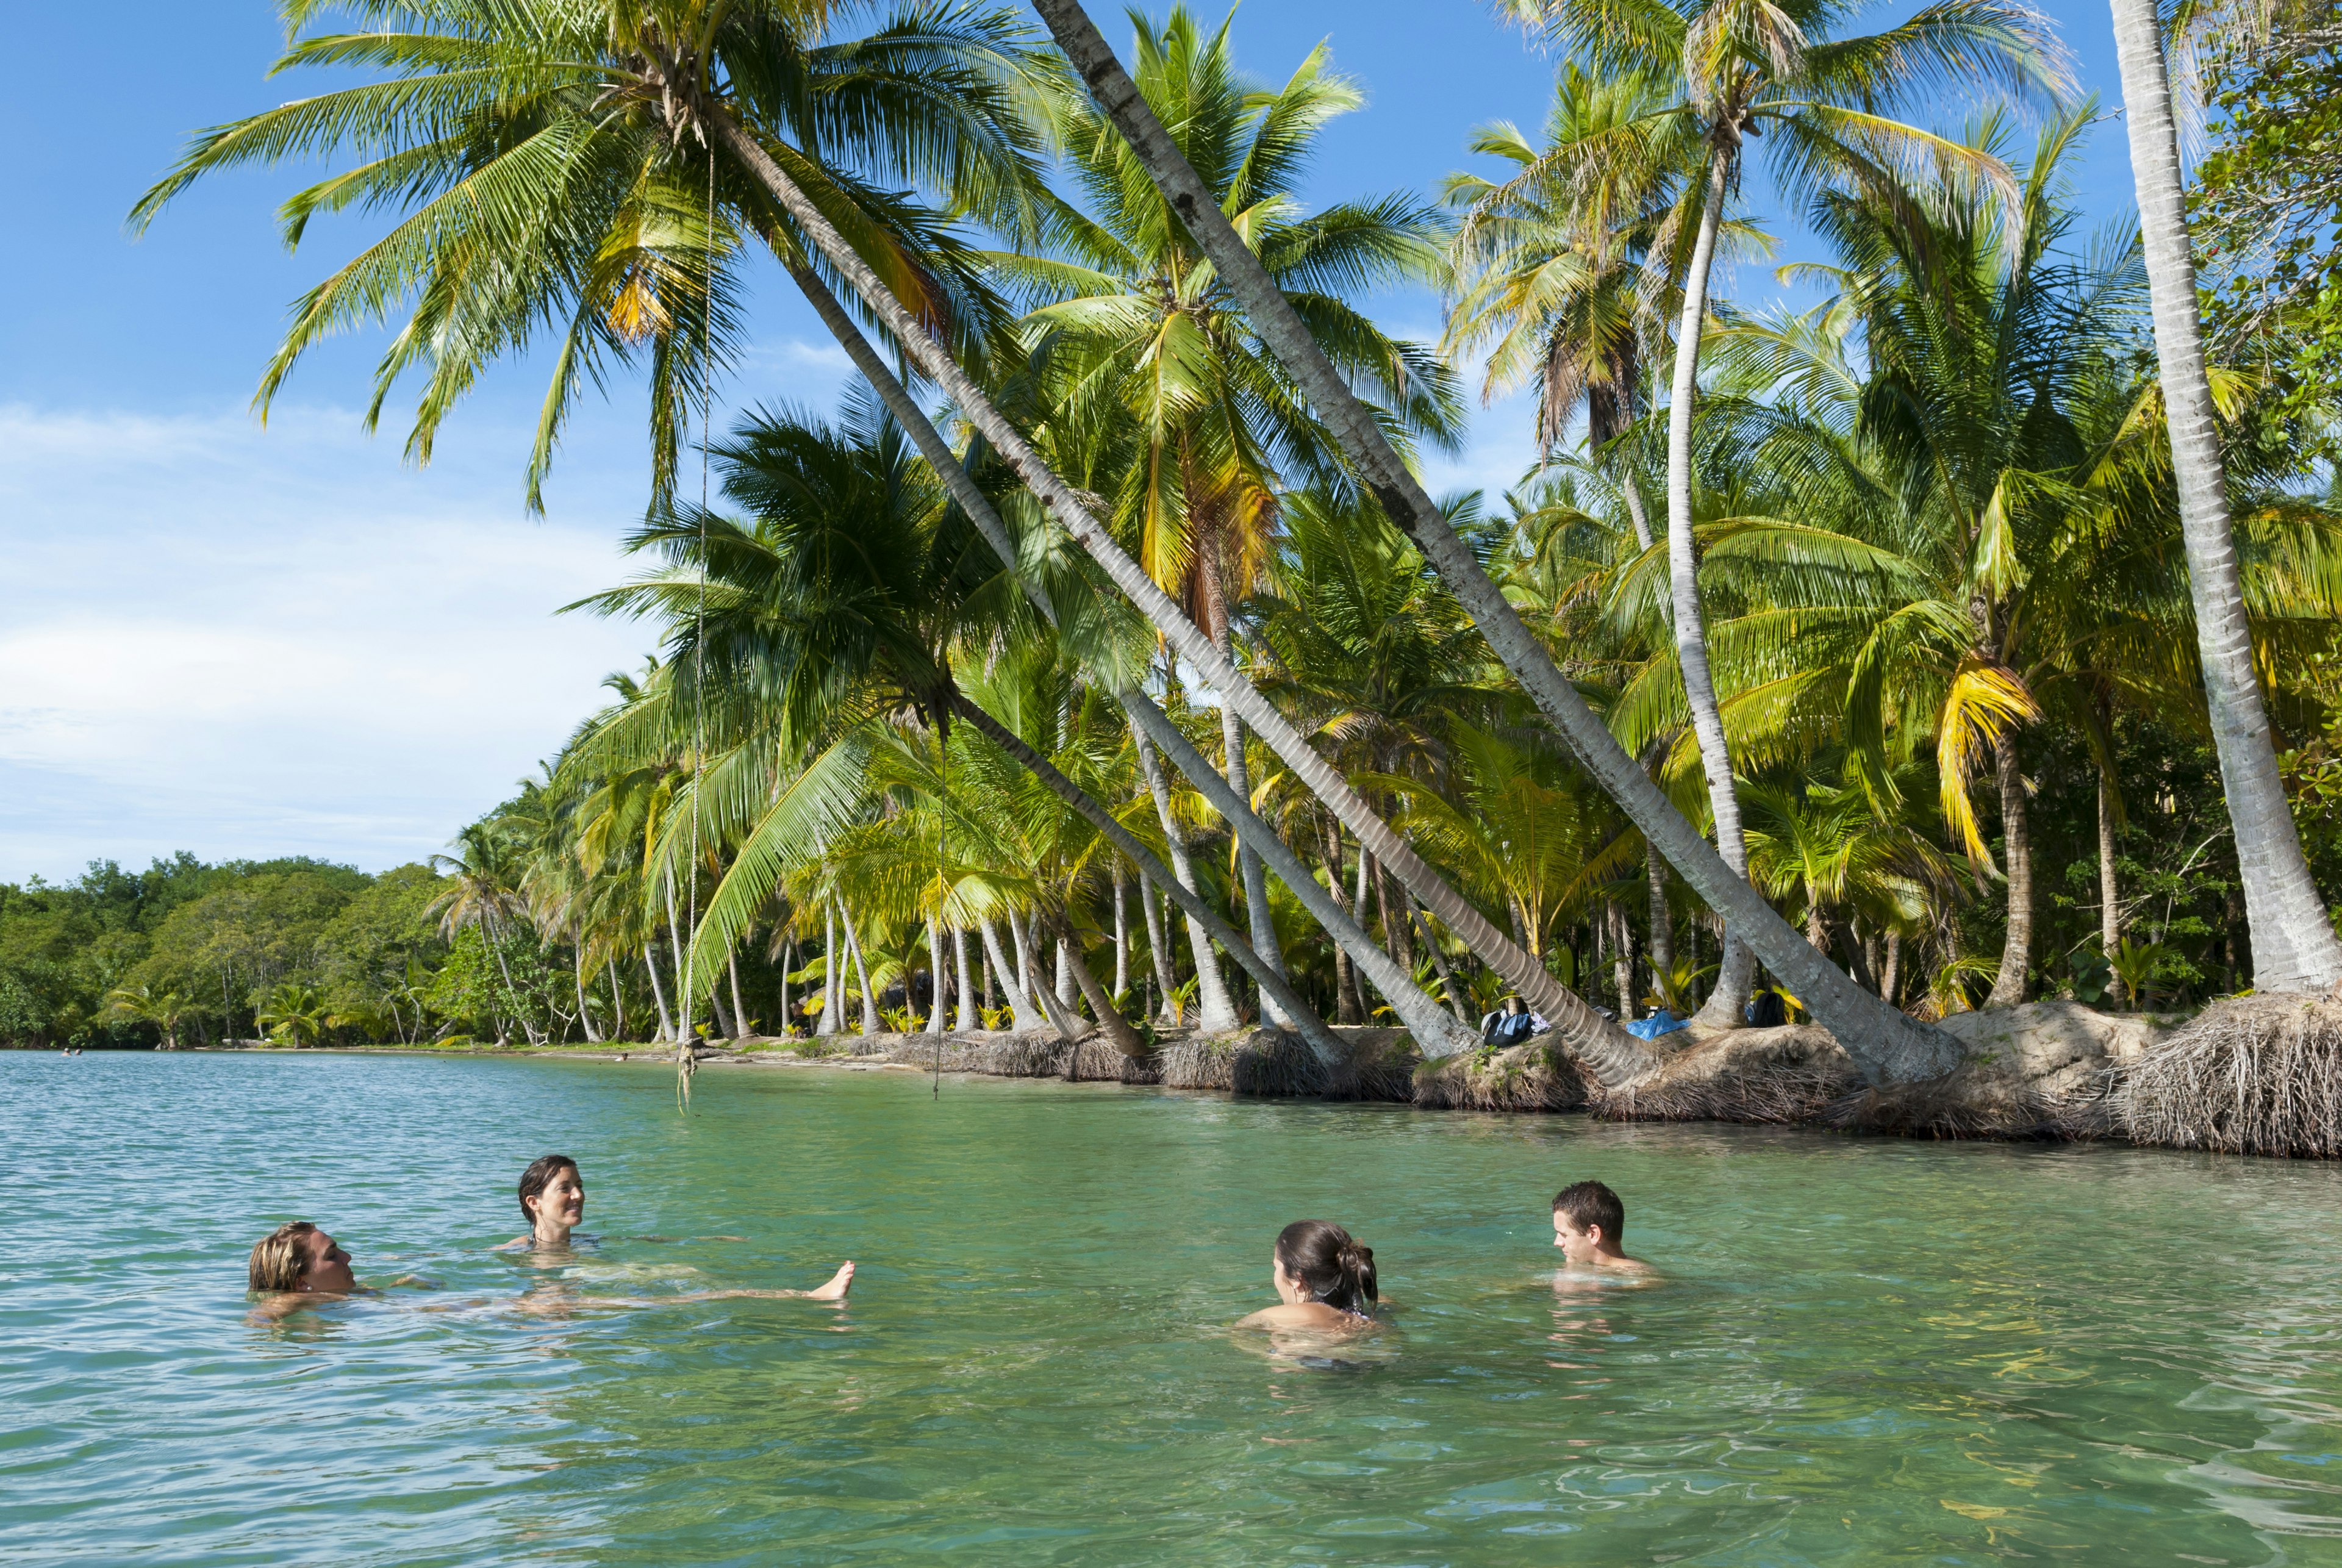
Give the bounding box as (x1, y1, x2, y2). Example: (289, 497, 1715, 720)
(2113, 0, 2342, 992)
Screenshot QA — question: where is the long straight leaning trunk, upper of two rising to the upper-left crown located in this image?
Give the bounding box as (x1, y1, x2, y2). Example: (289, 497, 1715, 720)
(705, 123, 1658, 1084)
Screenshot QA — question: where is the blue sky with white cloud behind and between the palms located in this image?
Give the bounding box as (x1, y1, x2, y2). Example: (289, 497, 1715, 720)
(0, 0, 2129, 880)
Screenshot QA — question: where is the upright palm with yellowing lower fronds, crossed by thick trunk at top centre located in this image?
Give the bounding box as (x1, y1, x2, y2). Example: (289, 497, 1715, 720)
(993, 7, 1456, 1006)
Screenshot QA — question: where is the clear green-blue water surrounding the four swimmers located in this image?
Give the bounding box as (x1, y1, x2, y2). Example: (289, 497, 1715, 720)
(0, 1053, 2342, 1568)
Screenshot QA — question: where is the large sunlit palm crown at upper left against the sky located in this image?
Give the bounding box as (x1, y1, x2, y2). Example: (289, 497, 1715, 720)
(134, 0, 1042, 501)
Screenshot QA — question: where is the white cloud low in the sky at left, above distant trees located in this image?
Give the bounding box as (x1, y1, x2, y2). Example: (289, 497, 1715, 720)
(0, 405, 649, 880)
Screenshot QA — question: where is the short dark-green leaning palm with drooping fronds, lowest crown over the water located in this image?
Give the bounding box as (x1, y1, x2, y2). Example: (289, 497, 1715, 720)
(583, 386, 1358, 1056)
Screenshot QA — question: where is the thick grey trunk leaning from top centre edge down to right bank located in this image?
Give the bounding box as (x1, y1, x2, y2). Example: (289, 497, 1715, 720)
(1035, 0, 1960, 1084)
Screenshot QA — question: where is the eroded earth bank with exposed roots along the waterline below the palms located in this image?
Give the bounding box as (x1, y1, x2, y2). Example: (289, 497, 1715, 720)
(177, 997, 2342, 1158)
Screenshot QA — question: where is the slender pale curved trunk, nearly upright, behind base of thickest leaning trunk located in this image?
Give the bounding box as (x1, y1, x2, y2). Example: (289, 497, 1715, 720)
(1667, 148, 1756, 1029)
